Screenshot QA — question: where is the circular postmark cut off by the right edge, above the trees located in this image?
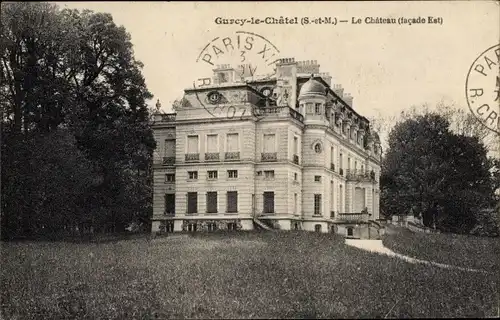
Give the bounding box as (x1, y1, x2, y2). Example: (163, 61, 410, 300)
(465, 44, 500, 135)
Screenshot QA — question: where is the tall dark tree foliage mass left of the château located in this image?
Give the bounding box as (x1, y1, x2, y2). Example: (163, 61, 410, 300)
(0, 3, 155, 238)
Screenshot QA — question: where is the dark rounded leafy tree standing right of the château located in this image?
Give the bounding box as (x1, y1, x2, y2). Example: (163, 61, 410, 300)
(381, 113, 493, 232)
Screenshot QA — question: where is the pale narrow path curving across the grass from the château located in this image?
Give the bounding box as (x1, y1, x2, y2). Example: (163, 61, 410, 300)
(345, 239, 489, 273)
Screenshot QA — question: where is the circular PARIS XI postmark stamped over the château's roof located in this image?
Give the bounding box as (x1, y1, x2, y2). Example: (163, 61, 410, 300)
(193, 31, 280, 120)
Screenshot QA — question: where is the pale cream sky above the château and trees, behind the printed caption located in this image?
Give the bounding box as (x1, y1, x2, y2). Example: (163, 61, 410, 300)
(57, 1, 500, 142)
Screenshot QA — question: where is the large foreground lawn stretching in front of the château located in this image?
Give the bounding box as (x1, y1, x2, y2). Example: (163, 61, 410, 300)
(1, 232, 498, 319)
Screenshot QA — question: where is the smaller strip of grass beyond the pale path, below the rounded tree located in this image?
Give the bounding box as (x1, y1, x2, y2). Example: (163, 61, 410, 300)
(383, 226, 500, 272)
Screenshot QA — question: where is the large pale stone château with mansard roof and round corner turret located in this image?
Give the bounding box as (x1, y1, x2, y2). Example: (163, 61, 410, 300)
(152, 58, 381, 237)
